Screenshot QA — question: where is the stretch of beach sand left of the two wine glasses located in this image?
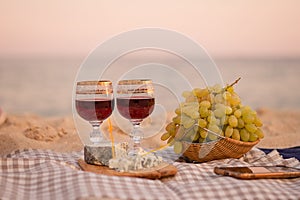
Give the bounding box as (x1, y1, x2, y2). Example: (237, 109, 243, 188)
(0, 114, 83, 156)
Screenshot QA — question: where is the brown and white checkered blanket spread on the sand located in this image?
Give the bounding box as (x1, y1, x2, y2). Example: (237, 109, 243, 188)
(0, 148, 300, 200)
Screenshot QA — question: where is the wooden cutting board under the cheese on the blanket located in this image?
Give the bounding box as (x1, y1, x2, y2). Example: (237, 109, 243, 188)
(78, 159, 177, 179)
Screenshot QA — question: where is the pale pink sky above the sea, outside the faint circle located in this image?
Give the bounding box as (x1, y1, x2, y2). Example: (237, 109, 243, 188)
(0, 0, 300, 57)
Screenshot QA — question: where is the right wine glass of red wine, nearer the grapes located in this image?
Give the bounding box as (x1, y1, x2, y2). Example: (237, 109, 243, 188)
(116, 79, 155, 156)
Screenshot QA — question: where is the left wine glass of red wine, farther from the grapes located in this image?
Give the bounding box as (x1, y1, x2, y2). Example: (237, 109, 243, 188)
(75, 80, 114, 144)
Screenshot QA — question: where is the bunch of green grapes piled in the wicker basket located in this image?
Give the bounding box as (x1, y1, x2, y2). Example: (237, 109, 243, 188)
(161, 78, 264, 153)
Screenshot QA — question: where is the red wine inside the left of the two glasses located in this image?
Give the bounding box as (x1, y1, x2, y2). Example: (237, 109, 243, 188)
(76, 99, 114, 121)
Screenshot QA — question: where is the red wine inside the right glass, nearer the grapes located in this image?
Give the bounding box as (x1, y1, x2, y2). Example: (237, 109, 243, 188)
(117, 96, 155, 119)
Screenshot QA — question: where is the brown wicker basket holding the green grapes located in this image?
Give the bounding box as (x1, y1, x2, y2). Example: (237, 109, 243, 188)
(178, 126, 259, 162)
